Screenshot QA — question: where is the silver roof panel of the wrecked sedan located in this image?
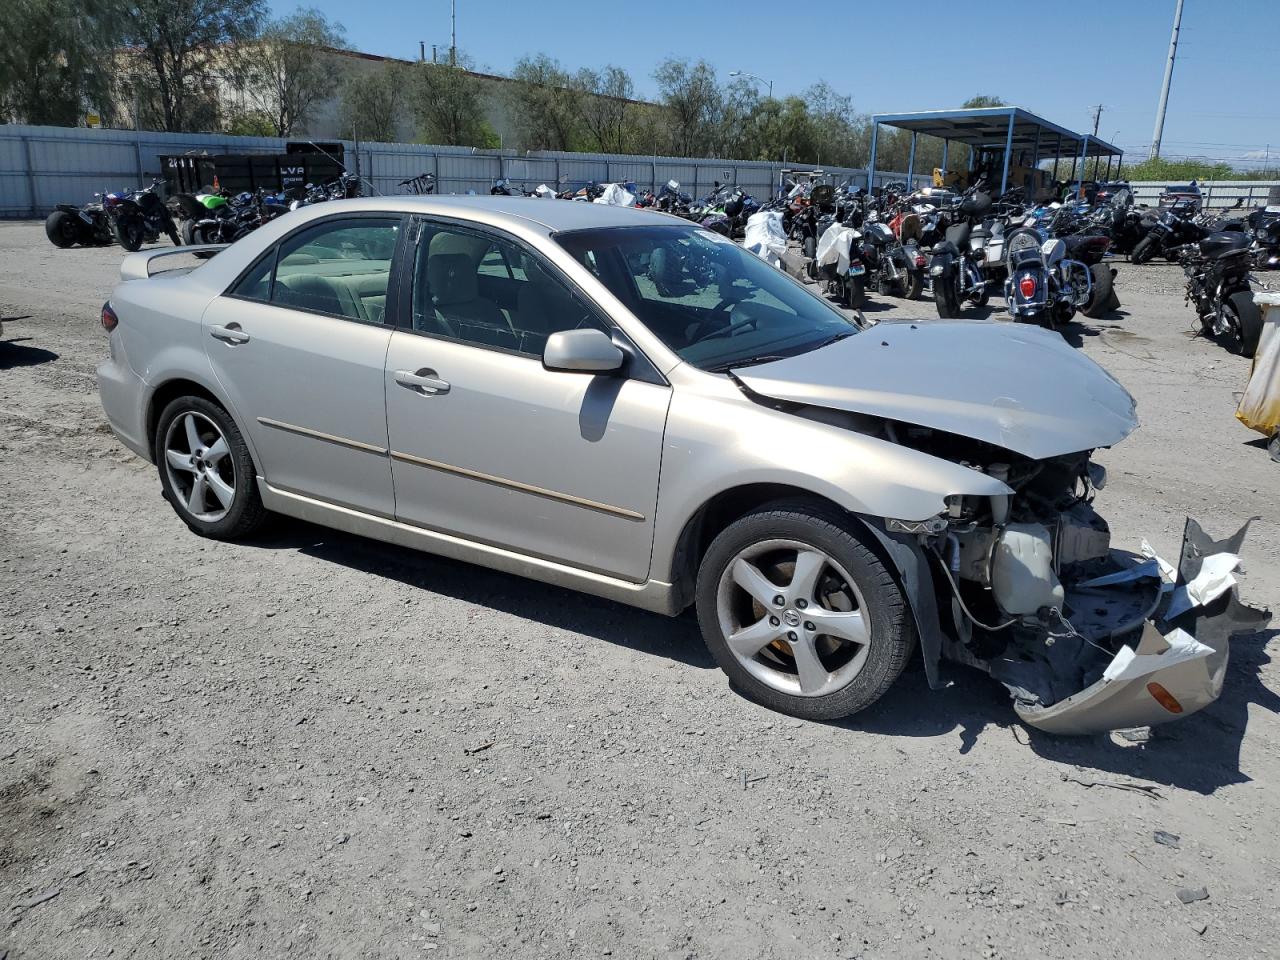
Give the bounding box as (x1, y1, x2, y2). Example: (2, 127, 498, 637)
(300, 195, 689, 233)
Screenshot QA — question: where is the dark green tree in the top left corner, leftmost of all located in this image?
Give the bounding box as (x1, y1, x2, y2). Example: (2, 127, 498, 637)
(0, 0, 119, 127)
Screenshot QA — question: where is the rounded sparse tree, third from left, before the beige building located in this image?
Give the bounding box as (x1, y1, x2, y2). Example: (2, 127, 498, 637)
(237, 8, 346, 137)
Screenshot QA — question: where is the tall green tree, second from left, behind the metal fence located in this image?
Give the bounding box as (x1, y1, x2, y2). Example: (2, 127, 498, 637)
(123, 0, 266, 131)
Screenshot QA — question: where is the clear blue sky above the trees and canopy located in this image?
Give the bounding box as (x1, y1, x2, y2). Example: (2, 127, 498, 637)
(270, 0, 1280, 164)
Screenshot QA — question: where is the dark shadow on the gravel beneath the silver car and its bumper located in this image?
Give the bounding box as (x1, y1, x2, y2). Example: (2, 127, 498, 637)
(244, 520, 1280, 794)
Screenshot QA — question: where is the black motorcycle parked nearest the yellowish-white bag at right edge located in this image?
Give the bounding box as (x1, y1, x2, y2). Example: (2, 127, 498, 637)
(1179, 230, 1262, 357)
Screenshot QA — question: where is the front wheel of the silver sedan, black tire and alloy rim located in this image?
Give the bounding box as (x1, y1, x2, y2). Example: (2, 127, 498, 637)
(698, 502, 915, 719)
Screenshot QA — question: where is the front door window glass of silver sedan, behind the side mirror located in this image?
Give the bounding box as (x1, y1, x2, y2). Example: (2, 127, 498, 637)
(413, 224, 608, 357)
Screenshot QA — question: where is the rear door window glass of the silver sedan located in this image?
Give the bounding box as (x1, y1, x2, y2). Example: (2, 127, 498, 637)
(233, 218, 401, 324)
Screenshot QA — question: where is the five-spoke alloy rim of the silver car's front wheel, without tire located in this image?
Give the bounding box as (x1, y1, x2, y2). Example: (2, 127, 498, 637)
(716, 540, 872, 696)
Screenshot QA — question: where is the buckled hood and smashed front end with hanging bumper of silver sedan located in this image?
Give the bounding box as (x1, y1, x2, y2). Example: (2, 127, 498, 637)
(739, 321, 1270, 733)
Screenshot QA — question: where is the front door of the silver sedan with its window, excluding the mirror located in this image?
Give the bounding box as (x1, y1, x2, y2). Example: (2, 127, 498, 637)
(387, 221, 669, 582)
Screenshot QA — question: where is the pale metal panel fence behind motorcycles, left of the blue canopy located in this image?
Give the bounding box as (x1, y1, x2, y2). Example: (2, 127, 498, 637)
(0, 124, 929, 218)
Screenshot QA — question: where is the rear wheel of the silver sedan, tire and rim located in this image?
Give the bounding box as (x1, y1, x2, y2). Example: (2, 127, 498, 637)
(155, 397, 266, 540)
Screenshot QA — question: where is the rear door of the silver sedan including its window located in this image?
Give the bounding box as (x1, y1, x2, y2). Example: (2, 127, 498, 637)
(204, 214, 404, 517)
